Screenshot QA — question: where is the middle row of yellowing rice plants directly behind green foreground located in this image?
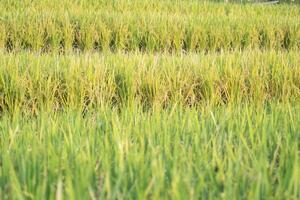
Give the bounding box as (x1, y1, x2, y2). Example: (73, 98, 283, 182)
(0, 50, 300, 114)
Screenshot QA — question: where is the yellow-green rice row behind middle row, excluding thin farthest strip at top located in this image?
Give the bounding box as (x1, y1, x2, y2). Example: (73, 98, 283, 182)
(0, 4, 300, 52)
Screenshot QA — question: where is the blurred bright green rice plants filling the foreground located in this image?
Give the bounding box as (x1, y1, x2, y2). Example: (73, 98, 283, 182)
(0, 104, 300, 199)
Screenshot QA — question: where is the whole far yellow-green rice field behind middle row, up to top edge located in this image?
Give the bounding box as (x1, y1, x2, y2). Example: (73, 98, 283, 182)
(0, 0, 300, 53)
